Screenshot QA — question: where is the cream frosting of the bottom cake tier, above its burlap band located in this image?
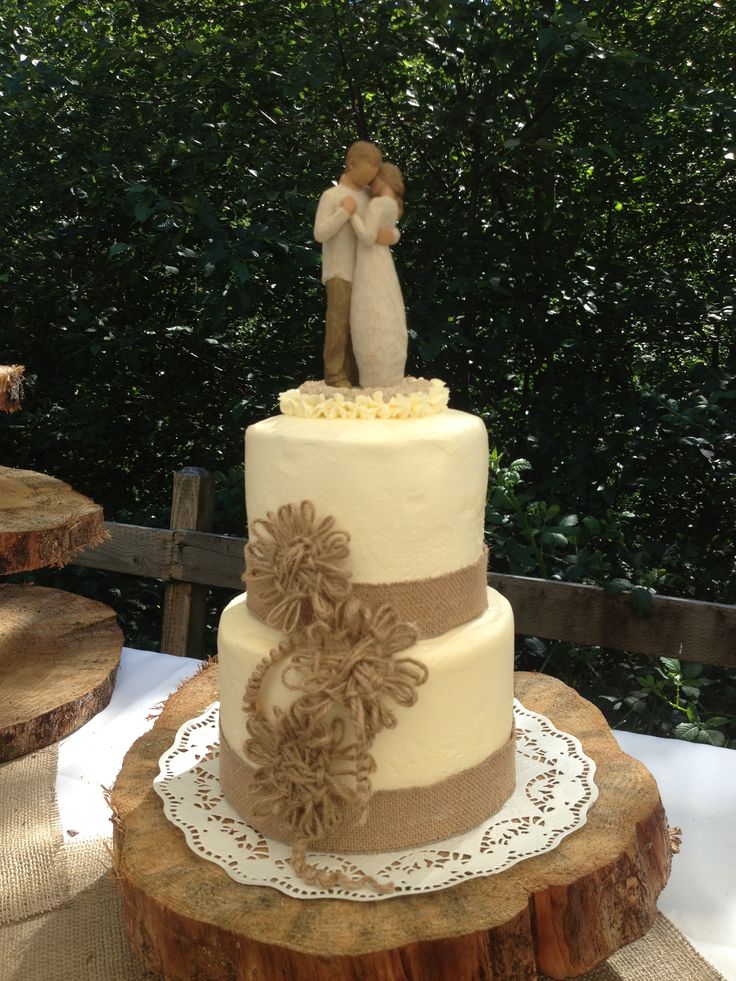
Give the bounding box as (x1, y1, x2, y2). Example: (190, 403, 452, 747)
(217, 589, 514, 788)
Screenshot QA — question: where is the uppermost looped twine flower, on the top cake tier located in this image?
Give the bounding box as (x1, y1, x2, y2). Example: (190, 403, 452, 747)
(245, 501, 350, 634)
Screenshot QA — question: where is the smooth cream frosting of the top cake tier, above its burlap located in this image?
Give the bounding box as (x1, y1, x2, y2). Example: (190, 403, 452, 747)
(245, 409, 488, 583)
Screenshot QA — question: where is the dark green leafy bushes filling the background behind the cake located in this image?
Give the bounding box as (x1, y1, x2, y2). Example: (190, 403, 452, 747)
(0, 0, 736, 745)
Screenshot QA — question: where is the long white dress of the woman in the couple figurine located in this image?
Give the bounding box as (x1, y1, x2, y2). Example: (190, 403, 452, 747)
(350, 197, 407, 388)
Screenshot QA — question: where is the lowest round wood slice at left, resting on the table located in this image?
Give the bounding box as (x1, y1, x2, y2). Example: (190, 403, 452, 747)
(0, 584, 123, 763)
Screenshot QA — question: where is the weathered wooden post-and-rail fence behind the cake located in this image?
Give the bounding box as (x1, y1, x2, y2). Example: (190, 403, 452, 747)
(70, 467, 736, 667)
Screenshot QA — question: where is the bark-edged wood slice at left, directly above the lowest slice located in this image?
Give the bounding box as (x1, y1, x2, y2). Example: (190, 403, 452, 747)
(0, 467, 110, 575)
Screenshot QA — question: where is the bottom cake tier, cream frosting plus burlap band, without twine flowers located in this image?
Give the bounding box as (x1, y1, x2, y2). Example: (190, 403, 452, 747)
(218, 589, 514, 852)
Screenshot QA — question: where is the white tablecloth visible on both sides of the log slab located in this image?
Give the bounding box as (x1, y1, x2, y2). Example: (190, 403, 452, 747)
(57, 648, 736, 981)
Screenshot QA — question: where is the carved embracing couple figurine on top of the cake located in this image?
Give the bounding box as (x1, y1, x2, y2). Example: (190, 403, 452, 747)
(314, 140, 407, 388)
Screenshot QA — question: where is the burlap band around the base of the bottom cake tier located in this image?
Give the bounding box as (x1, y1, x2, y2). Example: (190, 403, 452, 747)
(220, 730, 516, 853)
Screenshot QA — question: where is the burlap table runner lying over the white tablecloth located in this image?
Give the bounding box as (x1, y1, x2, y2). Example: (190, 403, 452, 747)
(0, 746, 725, 981)
